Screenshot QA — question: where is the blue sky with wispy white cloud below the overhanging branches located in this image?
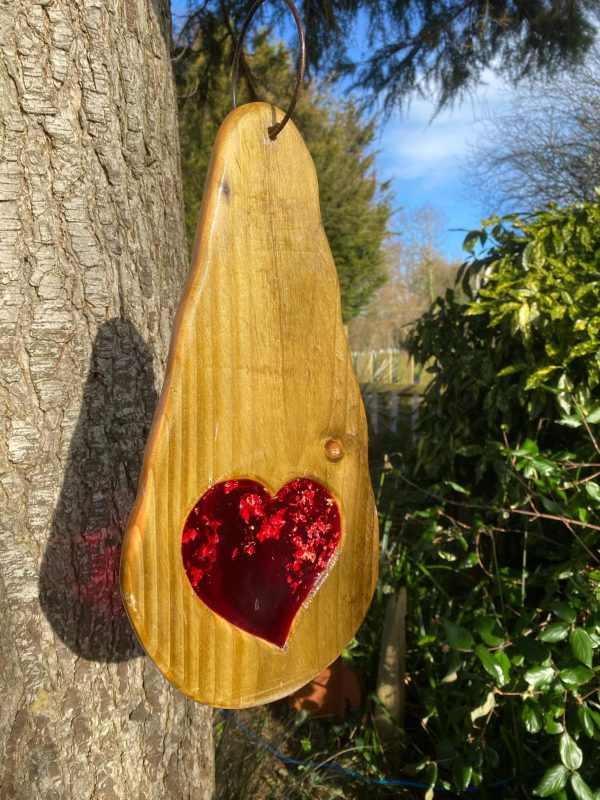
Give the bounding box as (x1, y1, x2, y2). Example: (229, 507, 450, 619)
(171, 0, 510, 260)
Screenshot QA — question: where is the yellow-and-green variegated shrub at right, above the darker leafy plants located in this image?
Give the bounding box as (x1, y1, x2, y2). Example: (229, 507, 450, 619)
(409, 204, 600, 485)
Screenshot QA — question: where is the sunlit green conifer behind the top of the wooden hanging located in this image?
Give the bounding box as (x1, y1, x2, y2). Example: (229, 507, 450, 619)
(177, 32, 392, 320)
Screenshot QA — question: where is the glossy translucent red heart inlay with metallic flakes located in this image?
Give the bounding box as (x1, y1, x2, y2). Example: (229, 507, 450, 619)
(181, 478, 341, 647)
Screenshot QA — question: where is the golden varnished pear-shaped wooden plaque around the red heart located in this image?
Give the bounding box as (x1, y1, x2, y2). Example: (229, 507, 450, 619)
(121, 103, 378, 708)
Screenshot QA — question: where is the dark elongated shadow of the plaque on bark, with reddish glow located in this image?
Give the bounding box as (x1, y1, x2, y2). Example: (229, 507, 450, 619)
(40, 319, 158, 662)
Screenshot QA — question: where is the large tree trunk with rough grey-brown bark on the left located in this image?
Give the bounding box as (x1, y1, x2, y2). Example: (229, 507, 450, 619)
(0, 0, 213, 800)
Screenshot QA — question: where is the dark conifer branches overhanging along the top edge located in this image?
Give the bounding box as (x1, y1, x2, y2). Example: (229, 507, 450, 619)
(176, 0, 597, 108)
